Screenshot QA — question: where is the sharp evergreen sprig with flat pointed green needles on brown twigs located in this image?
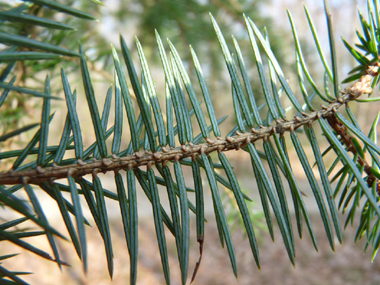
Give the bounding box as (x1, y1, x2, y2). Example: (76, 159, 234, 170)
(0, 0, 380, 284)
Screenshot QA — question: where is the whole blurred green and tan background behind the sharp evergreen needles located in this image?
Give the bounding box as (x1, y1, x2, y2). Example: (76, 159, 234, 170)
(0, 0, 380, 284)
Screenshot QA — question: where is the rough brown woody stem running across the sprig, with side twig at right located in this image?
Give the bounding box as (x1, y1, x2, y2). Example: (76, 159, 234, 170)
(0, 64, 379, 185)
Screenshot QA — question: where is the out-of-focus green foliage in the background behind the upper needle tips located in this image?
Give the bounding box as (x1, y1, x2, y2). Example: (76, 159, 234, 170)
(0, 0, 286, 142)
